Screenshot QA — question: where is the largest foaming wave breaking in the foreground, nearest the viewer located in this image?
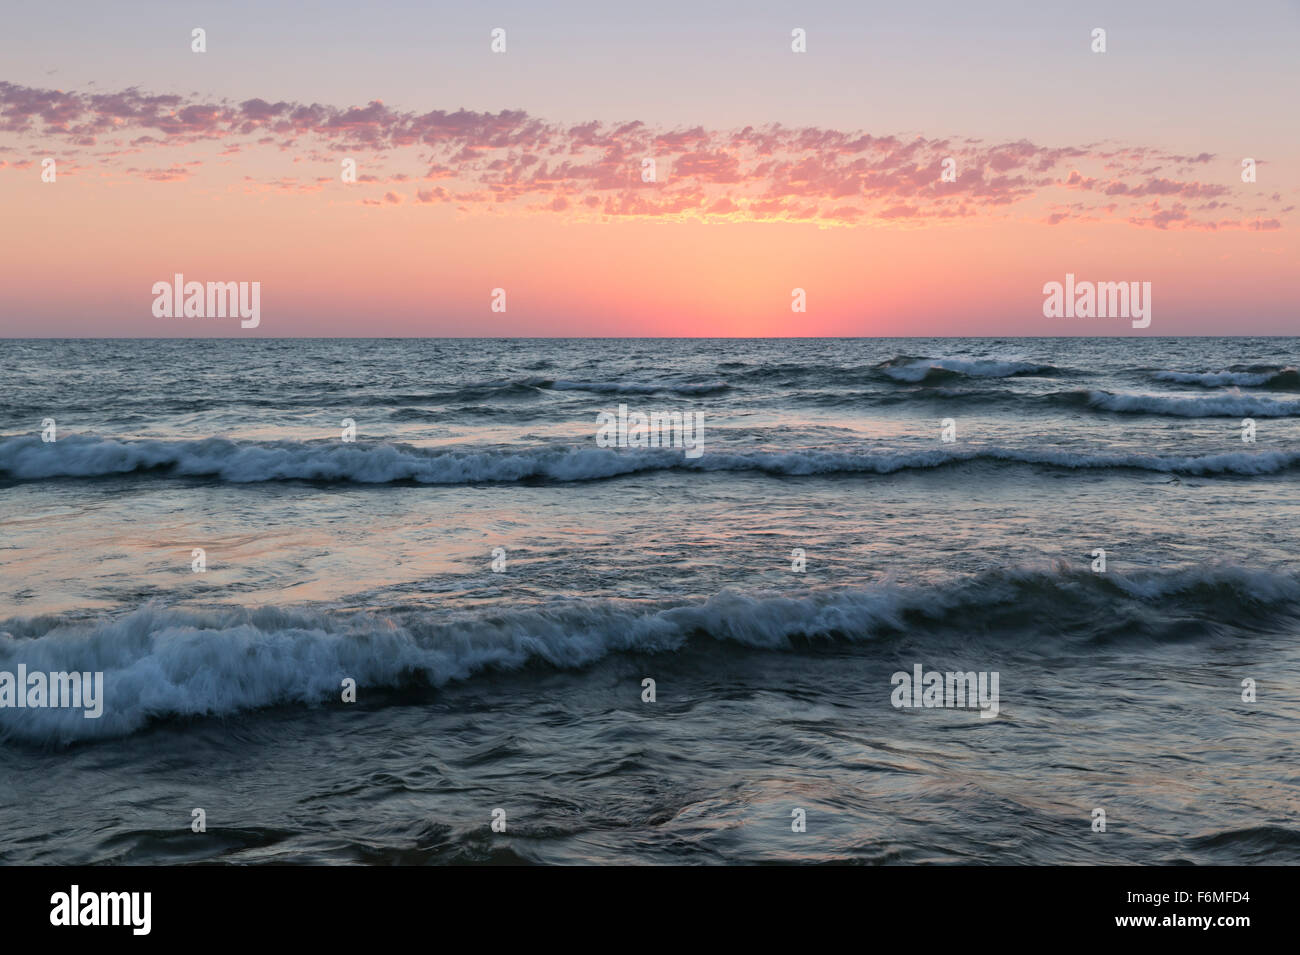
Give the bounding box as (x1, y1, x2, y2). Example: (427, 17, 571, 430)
(0, 565, 1300, 743)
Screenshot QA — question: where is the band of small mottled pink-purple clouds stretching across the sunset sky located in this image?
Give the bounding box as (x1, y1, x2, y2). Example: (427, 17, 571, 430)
(0, 82, 1284, 230)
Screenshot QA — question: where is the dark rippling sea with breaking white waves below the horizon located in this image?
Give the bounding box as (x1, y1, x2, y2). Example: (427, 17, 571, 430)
(0, 338, 1300, 863)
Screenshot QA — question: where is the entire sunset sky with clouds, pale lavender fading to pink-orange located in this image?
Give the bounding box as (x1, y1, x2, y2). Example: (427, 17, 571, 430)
(0, 0, 1300, 338)
